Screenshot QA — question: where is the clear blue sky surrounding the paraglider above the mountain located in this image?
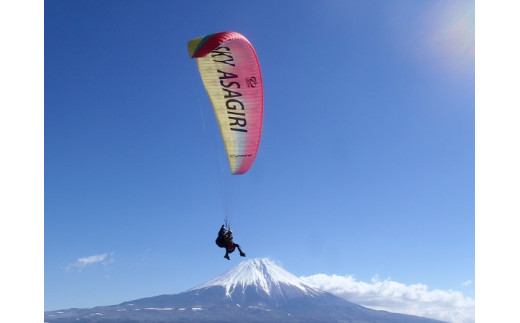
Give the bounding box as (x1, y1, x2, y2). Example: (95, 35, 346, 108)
(4, 1, 506, 321)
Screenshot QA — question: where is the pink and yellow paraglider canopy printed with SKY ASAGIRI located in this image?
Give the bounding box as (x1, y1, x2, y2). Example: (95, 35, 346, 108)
(188, 31, 264, 174)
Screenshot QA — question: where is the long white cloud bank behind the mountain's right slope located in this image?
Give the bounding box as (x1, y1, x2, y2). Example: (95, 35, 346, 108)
(300, 274, 475, 323)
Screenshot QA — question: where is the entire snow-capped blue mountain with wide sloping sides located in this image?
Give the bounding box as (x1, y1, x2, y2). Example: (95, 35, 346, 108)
(44, 259, 440, 323)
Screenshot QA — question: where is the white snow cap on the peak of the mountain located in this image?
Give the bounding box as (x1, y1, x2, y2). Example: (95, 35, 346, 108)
(192, 258, 322, 297)
